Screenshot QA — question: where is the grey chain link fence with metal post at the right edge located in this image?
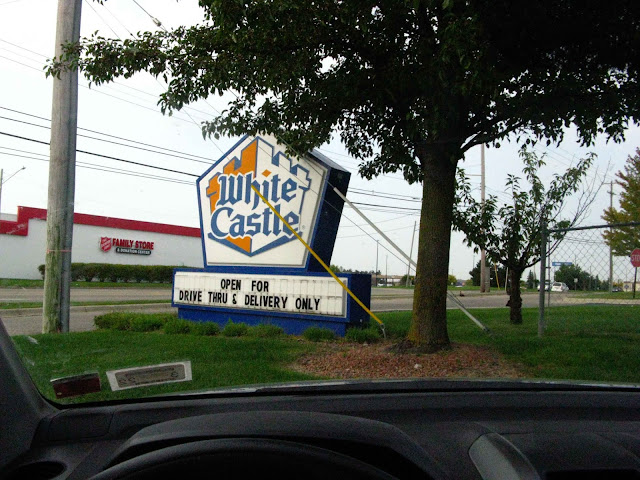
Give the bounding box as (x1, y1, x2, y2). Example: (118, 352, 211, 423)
(539, 223, 640, 335)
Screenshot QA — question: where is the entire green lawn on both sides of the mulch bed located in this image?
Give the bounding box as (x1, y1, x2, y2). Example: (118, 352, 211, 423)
(14, 306, 640, 401)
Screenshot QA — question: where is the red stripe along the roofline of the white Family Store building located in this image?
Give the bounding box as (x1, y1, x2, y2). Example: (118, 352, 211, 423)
(0, 207, 200, 237)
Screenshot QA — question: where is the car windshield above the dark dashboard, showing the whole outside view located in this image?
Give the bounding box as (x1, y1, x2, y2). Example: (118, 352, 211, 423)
(0, 0, 640, 403)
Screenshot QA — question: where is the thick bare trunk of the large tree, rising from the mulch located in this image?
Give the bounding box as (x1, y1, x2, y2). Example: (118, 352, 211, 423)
(407, 149, 457, 352)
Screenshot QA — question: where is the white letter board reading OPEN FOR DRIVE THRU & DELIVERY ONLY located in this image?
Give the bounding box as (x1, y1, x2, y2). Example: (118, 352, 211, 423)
(173, 272, 348, 317)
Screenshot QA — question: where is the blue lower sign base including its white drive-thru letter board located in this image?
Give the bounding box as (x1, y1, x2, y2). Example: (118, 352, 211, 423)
(172, 267, 371, 336)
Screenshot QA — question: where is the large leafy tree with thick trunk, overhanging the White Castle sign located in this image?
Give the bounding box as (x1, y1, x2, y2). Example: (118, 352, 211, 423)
(48, 0, 640, 351)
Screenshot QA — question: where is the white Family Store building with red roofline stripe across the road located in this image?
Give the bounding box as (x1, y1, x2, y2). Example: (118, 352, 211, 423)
(0, 207, 203, 279)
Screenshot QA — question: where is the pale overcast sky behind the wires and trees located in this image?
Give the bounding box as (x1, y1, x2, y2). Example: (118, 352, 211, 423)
(0, 0, 640, 278)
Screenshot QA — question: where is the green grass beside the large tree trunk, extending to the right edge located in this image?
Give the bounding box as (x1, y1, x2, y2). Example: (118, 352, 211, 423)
(379, 306, 640, 383)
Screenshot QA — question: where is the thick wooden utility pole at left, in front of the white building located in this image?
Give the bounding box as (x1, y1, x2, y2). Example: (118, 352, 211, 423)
(42, 0, 82, 333)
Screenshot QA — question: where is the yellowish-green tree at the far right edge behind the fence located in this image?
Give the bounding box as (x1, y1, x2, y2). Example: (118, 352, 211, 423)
(602, 148, 640, 256)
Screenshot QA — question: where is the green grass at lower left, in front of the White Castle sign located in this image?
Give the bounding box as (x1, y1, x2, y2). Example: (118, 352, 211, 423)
(13, 330, 314, 403)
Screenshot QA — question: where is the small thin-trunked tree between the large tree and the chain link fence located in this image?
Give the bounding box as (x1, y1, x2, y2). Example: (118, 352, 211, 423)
(453, 148, 602, 324)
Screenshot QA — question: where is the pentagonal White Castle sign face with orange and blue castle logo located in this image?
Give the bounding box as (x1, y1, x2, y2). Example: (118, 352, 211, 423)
(197, 136, 327, 267)
